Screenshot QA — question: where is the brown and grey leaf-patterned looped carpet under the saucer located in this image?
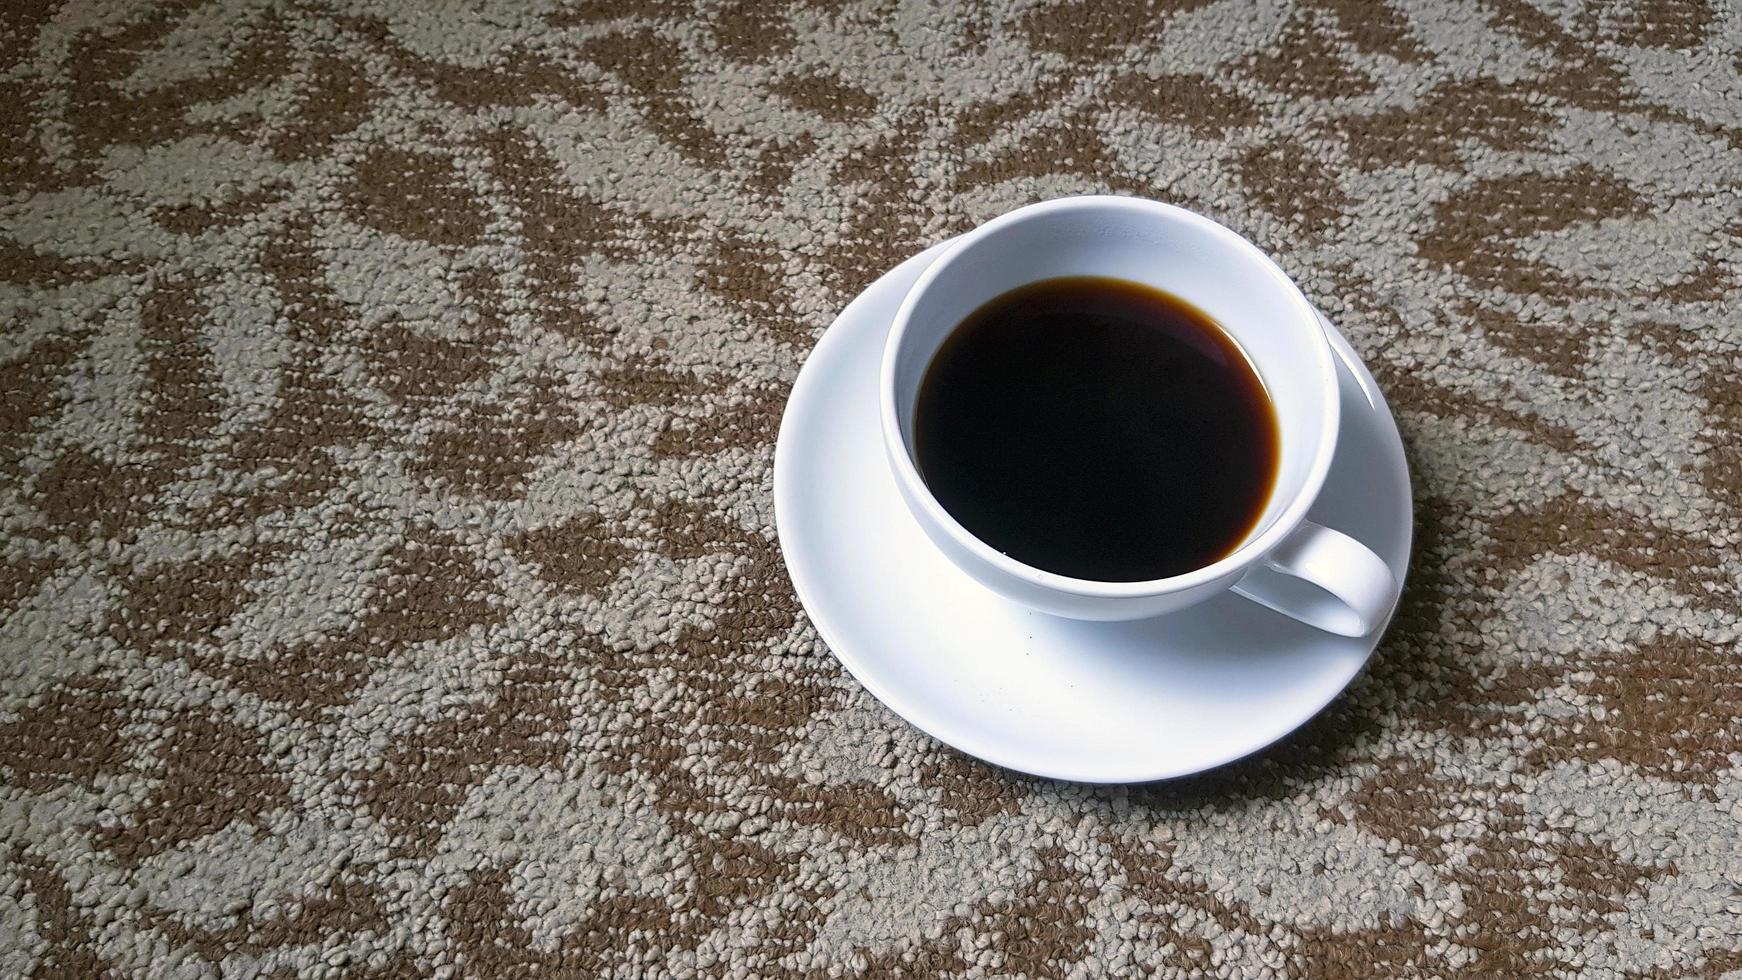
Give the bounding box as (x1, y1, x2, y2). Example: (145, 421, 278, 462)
(0, 0, 1742, 978)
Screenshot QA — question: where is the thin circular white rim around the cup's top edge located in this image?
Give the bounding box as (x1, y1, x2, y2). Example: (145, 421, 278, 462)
(878, 195, 1341, 599)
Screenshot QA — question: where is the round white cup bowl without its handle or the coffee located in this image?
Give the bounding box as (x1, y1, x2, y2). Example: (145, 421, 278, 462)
(883, 197, 1338, 618)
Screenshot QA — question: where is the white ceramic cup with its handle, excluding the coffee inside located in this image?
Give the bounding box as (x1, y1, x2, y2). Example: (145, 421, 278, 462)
(880, 197, 1395, 637)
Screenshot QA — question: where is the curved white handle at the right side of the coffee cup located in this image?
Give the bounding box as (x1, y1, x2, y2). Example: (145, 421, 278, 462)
(1233, 520, 1397, 637)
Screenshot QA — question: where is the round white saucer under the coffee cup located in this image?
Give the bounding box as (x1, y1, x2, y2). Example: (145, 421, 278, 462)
(773, 242, 1411, 783)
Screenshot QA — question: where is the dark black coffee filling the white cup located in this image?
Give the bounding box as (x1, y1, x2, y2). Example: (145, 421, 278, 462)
(913, 277, 1277, 581)
